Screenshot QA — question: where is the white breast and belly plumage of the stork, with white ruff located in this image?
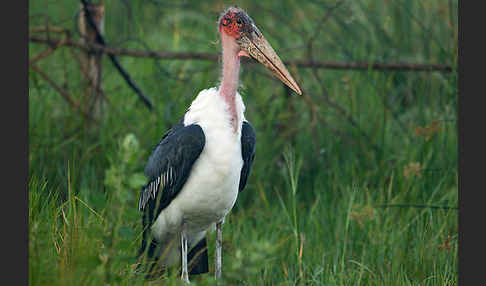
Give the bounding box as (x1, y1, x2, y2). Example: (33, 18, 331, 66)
(152, 88, 245, 241)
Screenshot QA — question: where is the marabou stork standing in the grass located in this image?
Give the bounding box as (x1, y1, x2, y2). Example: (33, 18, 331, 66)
(138, 7, 302, 282)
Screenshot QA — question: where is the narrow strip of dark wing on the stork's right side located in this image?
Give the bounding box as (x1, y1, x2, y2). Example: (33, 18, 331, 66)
(238, 121, 256, 192)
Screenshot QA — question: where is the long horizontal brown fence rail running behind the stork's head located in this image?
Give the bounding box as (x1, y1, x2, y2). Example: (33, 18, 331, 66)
(29, 35, 452, 72)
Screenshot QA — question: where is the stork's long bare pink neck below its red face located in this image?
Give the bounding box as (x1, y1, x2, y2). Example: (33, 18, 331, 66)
(219, 33, 240, 132)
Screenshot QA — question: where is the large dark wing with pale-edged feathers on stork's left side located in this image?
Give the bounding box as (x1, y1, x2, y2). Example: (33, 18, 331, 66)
(138, 120, 206, 214)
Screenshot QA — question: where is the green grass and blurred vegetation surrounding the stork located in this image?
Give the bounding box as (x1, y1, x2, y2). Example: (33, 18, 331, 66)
(29, 0, 458, 285)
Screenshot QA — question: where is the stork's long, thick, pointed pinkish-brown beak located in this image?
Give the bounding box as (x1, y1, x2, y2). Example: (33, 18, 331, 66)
(239, 30, 302, 95)
